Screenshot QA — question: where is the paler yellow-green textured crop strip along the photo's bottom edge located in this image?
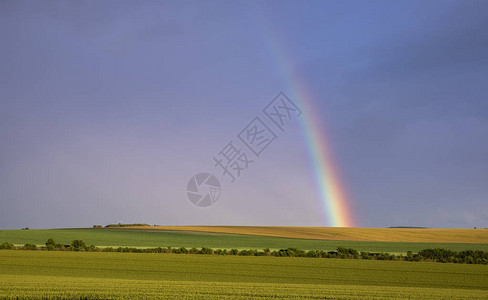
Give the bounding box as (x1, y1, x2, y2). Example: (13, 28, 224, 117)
(0, 275, 488, 299)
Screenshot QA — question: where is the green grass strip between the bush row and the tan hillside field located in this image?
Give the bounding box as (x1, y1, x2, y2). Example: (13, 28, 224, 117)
(0, 229, 488, 253)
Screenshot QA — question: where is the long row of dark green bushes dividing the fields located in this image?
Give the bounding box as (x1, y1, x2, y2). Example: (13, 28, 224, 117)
(0, 238, 488, 265)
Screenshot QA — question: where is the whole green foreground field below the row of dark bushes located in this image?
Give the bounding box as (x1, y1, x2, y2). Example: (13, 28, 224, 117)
(0, 250, 488, 299)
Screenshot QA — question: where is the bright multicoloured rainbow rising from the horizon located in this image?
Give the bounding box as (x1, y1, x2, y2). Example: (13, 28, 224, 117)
(268, 35, 355, 227)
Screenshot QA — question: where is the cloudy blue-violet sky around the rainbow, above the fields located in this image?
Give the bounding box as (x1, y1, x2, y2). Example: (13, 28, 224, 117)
(0, 0, 488, 228)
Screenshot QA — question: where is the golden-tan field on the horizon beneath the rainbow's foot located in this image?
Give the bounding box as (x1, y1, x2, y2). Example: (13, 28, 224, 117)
(125, 226, 488, 243)
